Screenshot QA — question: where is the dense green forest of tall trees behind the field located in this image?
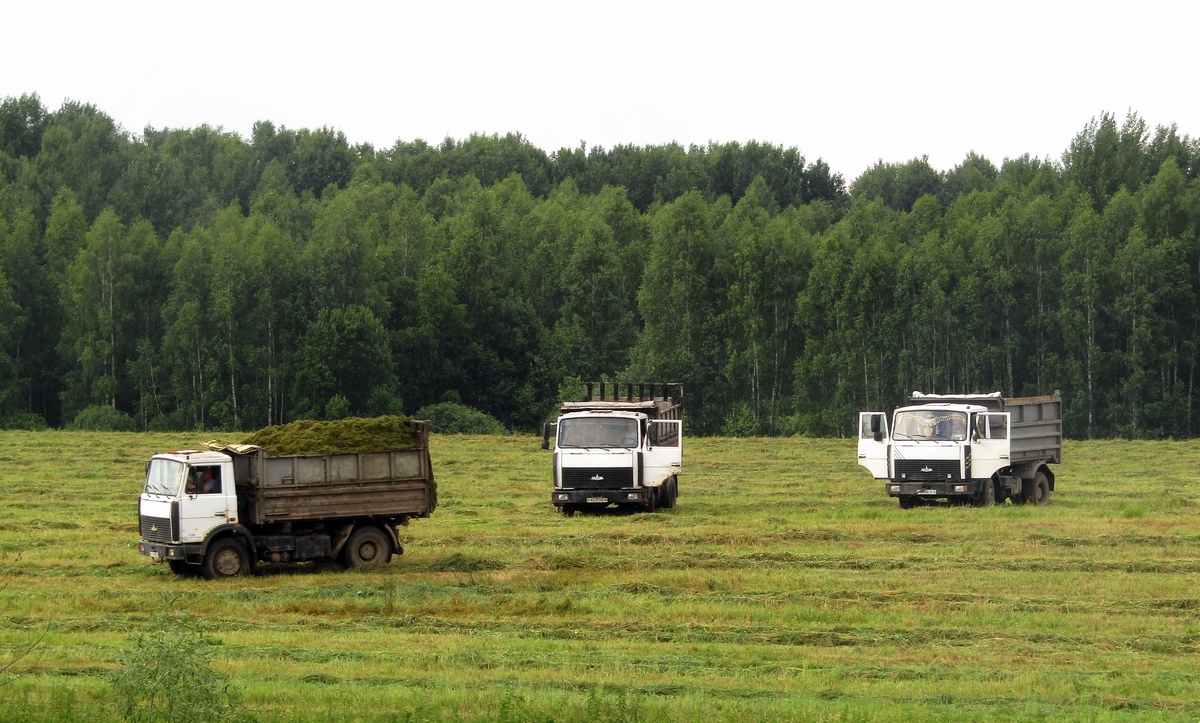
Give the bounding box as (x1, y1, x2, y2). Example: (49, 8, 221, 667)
(0, 95, 1200, 438)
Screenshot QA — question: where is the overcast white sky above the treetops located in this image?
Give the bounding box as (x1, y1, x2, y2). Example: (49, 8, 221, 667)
(0, 0, 1200, 183)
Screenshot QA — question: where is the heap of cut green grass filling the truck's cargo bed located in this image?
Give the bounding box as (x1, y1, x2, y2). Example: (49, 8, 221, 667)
(238, 416, 416, 456)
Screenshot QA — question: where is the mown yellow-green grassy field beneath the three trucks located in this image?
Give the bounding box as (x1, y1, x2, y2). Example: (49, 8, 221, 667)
(0, 432, 1200, 722)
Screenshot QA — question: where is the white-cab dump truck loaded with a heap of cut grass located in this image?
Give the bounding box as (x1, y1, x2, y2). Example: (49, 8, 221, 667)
(138, 417, 437, 579)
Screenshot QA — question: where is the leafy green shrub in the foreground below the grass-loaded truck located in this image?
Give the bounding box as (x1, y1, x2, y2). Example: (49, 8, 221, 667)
(109, 615, 240, 722)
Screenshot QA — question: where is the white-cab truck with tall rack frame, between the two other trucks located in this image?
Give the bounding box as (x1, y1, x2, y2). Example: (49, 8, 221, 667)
(542, 382, 683, 516)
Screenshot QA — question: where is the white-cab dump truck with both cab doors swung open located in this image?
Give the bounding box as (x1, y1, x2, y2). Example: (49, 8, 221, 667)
(858, 392, 1062, 509)
